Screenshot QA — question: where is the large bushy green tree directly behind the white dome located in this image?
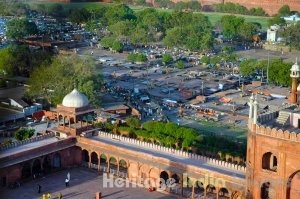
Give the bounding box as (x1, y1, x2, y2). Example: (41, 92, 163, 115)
(26, 55, 102, 105)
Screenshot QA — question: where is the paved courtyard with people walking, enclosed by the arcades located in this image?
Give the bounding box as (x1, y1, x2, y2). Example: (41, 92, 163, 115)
(0, 168, 178, 199)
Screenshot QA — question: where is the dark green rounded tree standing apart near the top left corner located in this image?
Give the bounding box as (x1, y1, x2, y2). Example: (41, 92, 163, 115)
(6, 18, 38, 40)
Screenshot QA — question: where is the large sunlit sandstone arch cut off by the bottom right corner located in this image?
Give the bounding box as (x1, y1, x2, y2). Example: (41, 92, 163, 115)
(286, 170, 300, 199)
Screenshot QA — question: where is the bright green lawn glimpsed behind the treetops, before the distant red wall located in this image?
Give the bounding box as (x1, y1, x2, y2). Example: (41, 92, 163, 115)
(29, 0, 269, 30)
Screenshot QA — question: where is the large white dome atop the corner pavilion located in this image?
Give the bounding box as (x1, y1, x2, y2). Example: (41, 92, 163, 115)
(62, 89, 89, 108)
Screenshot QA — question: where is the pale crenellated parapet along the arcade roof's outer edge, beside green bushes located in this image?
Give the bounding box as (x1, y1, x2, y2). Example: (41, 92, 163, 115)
(98, 131, 246, 172)
